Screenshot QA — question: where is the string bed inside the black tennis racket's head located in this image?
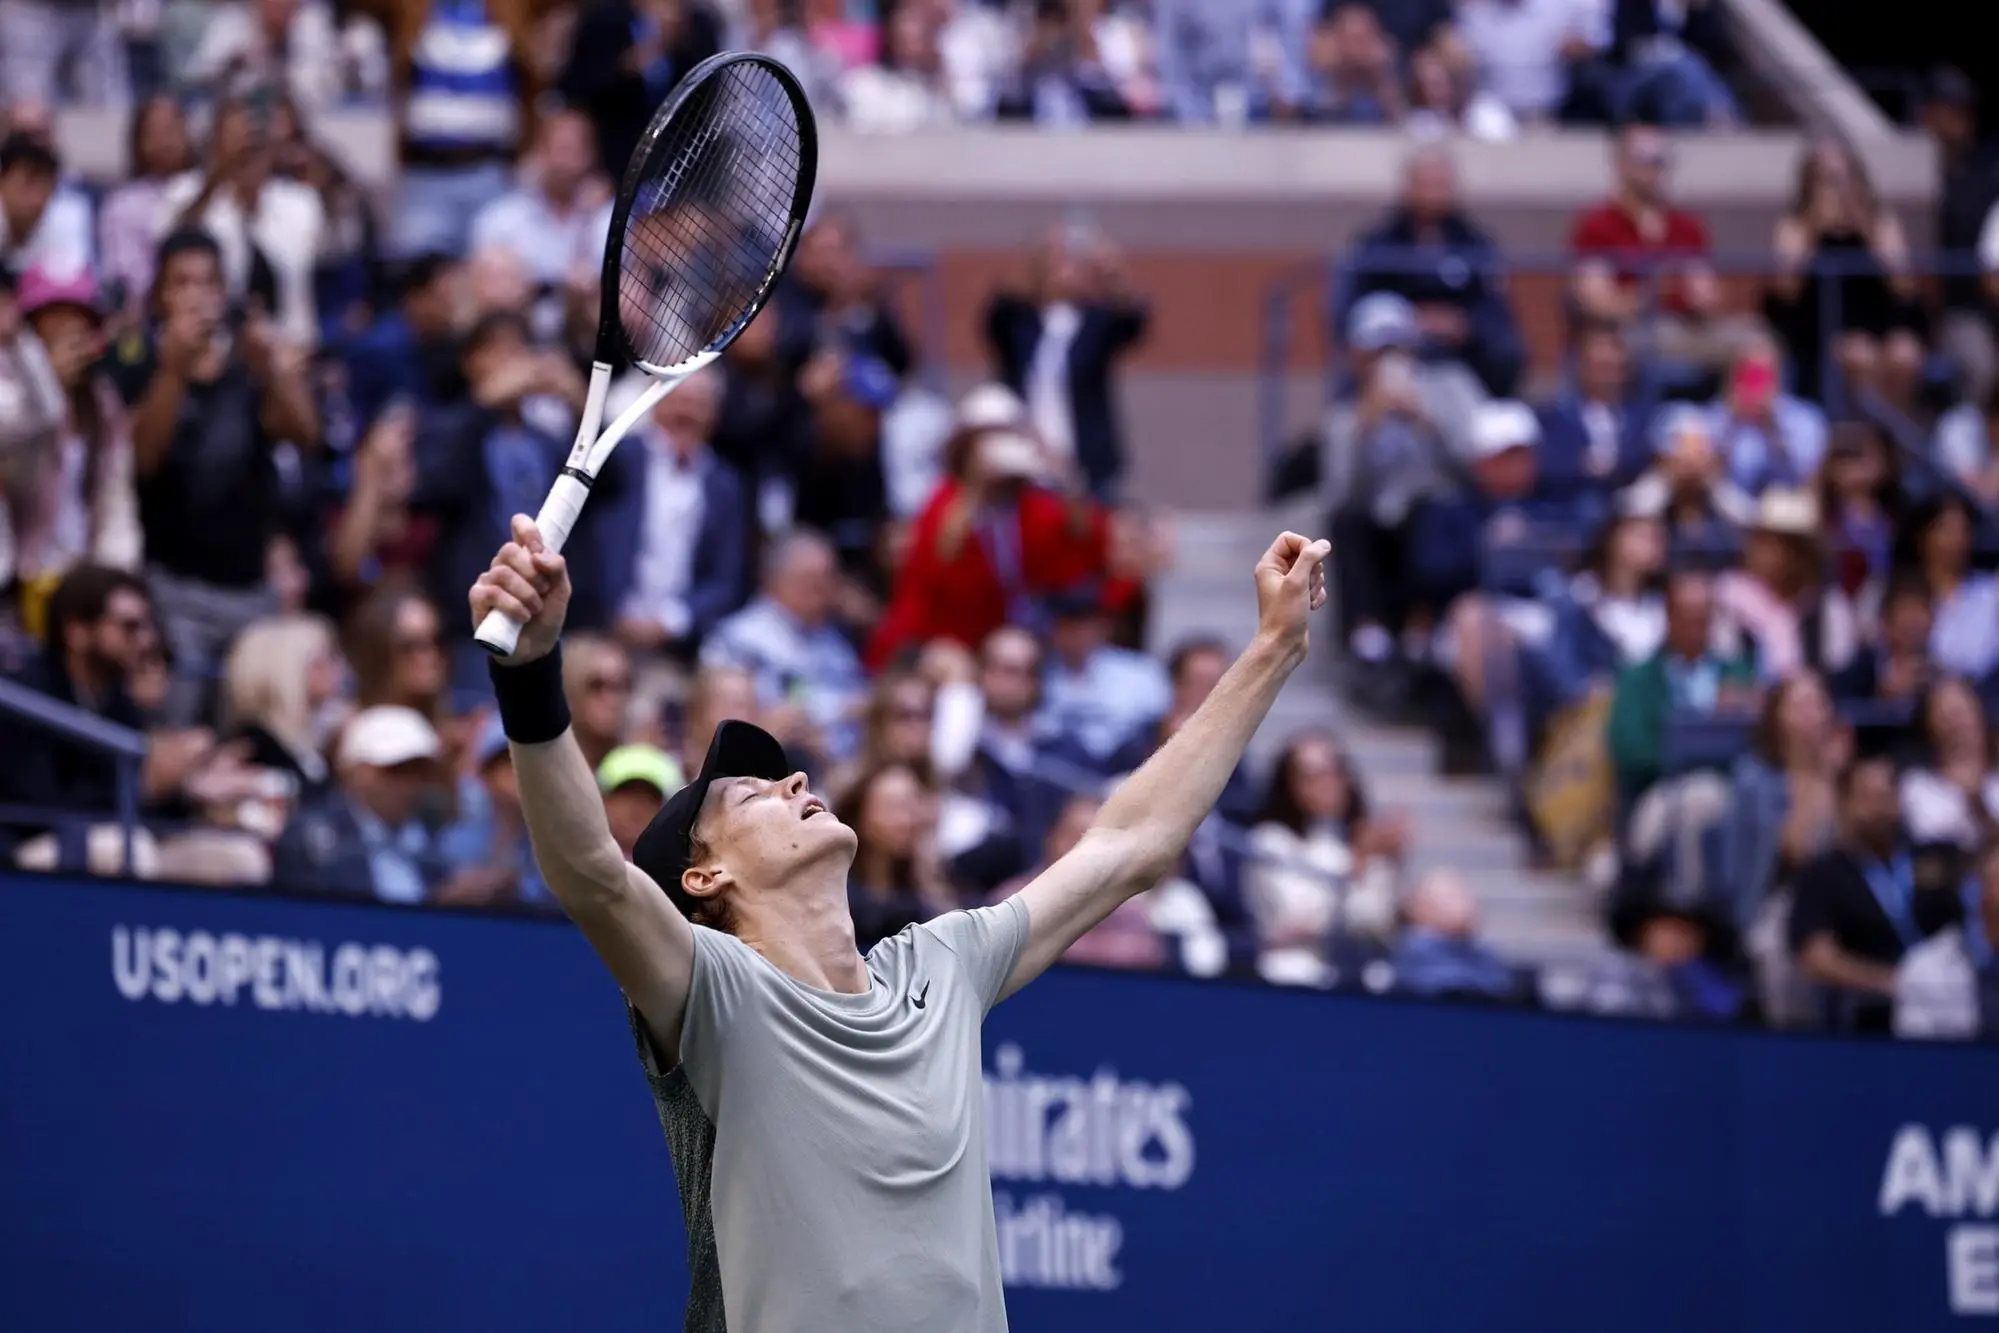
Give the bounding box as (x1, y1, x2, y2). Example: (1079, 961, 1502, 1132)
(618, 62, 802, 368)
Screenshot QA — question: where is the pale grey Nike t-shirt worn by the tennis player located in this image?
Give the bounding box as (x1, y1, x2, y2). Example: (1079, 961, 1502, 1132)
(632, 897, 1027, 1333)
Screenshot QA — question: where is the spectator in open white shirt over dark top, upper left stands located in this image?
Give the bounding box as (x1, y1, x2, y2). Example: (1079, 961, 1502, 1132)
(160, 100, 326, 348)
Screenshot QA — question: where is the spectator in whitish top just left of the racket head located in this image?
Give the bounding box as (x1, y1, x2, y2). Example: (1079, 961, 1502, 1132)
(472, 112, 610, 288)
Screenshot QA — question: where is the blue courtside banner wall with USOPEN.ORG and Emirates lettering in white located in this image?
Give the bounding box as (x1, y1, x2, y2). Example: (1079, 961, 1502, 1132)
(0, 877, 1999, 1333)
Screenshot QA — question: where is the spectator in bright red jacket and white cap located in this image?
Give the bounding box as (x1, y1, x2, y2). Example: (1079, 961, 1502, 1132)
(868, 409, 1131, 667)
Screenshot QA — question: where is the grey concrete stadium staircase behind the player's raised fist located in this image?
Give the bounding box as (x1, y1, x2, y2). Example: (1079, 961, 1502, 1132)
(1151, 510, 1609, 963)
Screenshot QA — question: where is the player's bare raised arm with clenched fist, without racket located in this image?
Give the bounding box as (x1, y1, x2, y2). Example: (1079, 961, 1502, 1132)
(1001, 532, 1331, 995)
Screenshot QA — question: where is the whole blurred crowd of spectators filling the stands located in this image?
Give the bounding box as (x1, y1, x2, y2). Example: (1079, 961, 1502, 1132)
(0, 0, 1999, 1037)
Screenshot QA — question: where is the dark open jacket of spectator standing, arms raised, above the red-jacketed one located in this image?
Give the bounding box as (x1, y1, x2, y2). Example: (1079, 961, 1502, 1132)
(986, 294, 1151, 496)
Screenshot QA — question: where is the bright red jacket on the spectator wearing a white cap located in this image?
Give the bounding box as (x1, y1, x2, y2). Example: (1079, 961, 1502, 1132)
(868, 482, 1135, 669)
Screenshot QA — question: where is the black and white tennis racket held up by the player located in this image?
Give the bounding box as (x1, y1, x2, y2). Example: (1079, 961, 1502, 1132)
(474, 54, 820, 658)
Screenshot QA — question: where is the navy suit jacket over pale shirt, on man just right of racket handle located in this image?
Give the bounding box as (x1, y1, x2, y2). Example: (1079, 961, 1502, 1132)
(570, 440, 750, 642)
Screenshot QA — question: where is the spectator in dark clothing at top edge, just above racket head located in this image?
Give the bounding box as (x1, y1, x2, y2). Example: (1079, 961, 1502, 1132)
(562, 0, 722, 174)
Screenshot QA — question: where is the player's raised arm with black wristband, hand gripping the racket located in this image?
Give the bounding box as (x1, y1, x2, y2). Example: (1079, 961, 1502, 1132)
(472, 514, 694, 1059)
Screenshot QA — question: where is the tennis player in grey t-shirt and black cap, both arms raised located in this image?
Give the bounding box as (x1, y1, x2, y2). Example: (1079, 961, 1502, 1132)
(472, 516, 1329, 1333)
